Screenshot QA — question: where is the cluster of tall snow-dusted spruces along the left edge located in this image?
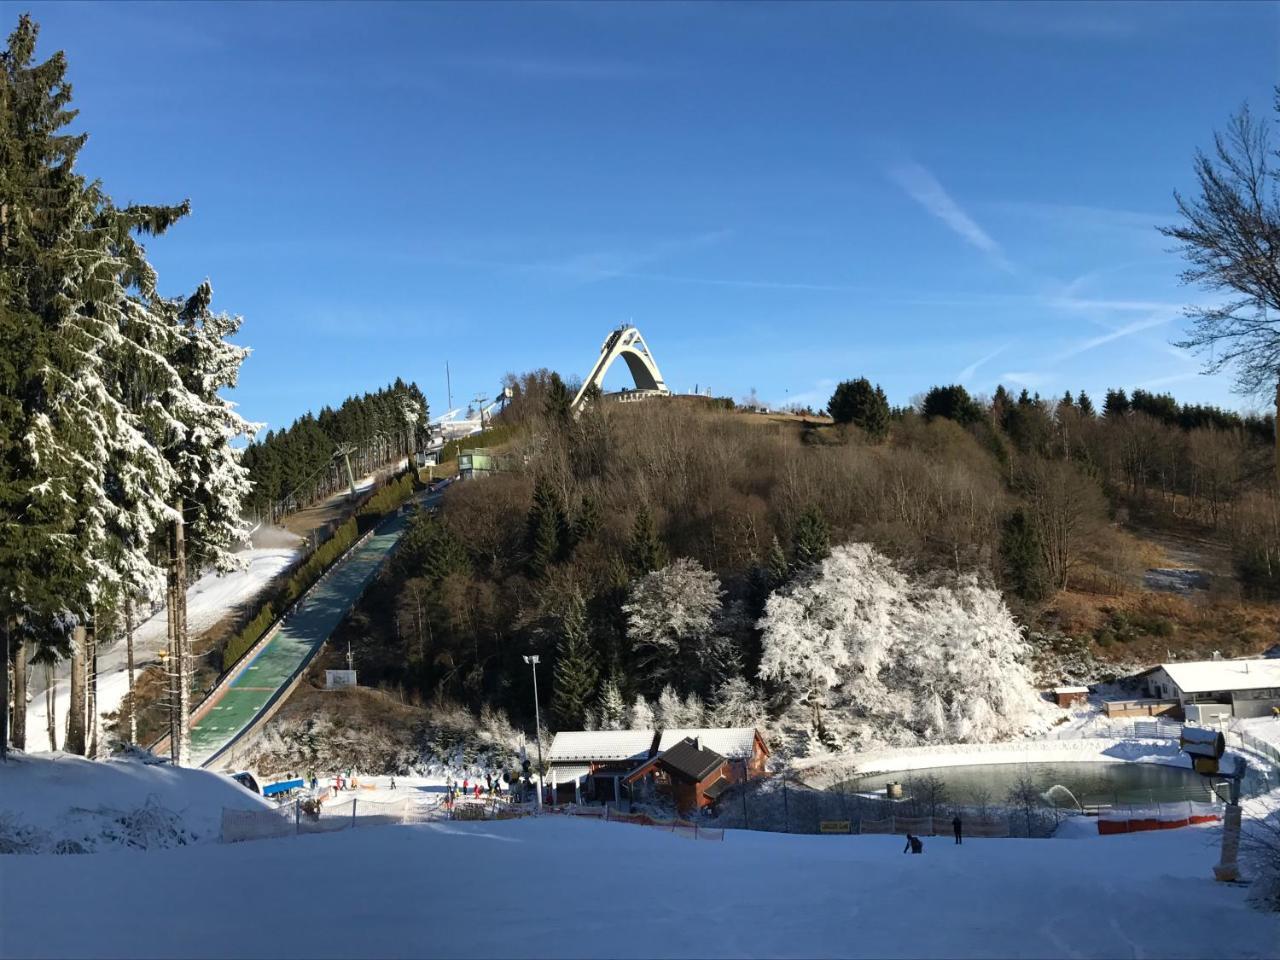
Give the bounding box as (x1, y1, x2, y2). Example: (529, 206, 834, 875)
(0, 18, 254, 751)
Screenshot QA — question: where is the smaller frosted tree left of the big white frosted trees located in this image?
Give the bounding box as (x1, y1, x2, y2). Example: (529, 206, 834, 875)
(622, 557, 723, 689)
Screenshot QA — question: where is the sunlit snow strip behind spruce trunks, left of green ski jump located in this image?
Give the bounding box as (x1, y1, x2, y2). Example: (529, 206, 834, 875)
(27, 547, 297, 753)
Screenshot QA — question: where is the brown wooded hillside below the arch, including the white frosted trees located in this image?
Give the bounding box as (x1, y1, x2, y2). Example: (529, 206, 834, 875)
(332, 371, 1280, 744)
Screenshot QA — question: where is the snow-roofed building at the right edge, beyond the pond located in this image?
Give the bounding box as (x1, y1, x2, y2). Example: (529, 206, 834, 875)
(1142, 659, 1280, 722)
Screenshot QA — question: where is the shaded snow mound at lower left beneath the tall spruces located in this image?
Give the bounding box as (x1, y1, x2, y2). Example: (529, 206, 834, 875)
(0, 754, 274, 854)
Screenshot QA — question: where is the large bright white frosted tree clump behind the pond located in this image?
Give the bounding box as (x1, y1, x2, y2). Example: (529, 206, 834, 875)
(759, 544, 1046, 746)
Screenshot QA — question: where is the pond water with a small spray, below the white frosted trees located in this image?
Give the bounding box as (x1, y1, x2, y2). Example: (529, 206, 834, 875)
(836, 763, 1211, 808)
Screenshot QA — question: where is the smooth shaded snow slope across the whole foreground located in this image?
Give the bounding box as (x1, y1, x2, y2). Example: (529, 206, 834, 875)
(0, 817, 1280, 957)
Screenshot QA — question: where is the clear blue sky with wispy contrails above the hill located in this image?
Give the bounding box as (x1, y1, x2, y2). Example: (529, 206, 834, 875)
(24, 3, 1280, 426)
